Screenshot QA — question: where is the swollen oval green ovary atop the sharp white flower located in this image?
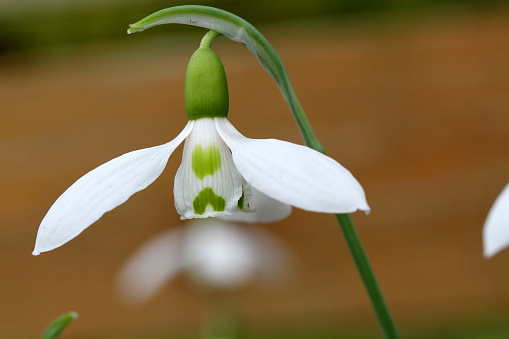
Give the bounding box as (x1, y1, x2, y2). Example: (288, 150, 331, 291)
(185, 46, 229, 120)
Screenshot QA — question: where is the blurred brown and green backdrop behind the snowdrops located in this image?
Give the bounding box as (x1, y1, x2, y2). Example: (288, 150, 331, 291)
(0, 0, 509, 338)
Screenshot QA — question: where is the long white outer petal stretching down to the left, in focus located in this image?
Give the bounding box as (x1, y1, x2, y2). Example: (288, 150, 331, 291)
(32, 121, 194, 255)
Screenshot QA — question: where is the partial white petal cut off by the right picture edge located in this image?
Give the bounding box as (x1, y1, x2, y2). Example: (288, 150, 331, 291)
(483, 184, 509, 258)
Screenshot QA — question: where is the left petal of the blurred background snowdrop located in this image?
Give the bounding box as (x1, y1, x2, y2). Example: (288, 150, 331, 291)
(115, 229, 185, 304)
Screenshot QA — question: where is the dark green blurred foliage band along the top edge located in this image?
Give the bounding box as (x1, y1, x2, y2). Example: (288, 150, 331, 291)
(0, 0, 501, 56)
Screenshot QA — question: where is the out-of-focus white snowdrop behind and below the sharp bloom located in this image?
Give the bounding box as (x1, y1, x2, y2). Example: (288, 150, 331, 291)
(115, 219, 291, 304)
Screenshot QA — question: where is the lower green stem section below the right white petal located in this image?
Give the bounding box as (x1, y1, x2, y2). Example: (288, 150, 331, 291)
(336, 214, 399, 339)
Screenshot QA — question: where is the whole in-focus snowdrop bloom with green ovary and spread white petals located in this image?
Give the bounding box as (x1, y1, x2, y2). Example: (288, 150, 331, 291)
(33, 35, 369, 255)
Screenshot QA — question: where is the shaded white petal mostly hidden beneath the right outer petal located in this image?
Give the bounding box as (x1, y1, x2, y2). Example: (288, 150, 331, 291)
(218, 187, 292, 223)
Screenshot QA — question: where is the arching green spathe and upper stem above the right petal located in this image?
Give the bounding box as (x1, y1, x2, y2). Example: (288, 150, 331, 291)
(127, 5, 323, 152)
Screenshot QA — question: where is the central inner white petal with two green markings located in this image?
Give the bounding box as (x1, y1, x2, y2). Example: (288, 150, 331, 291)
(174, 118, 242, 219)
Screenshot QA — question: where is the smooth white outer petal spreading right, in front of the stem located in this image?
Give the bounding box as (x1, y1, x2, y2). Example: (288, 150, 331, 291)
(215, 118, 369, 213)
